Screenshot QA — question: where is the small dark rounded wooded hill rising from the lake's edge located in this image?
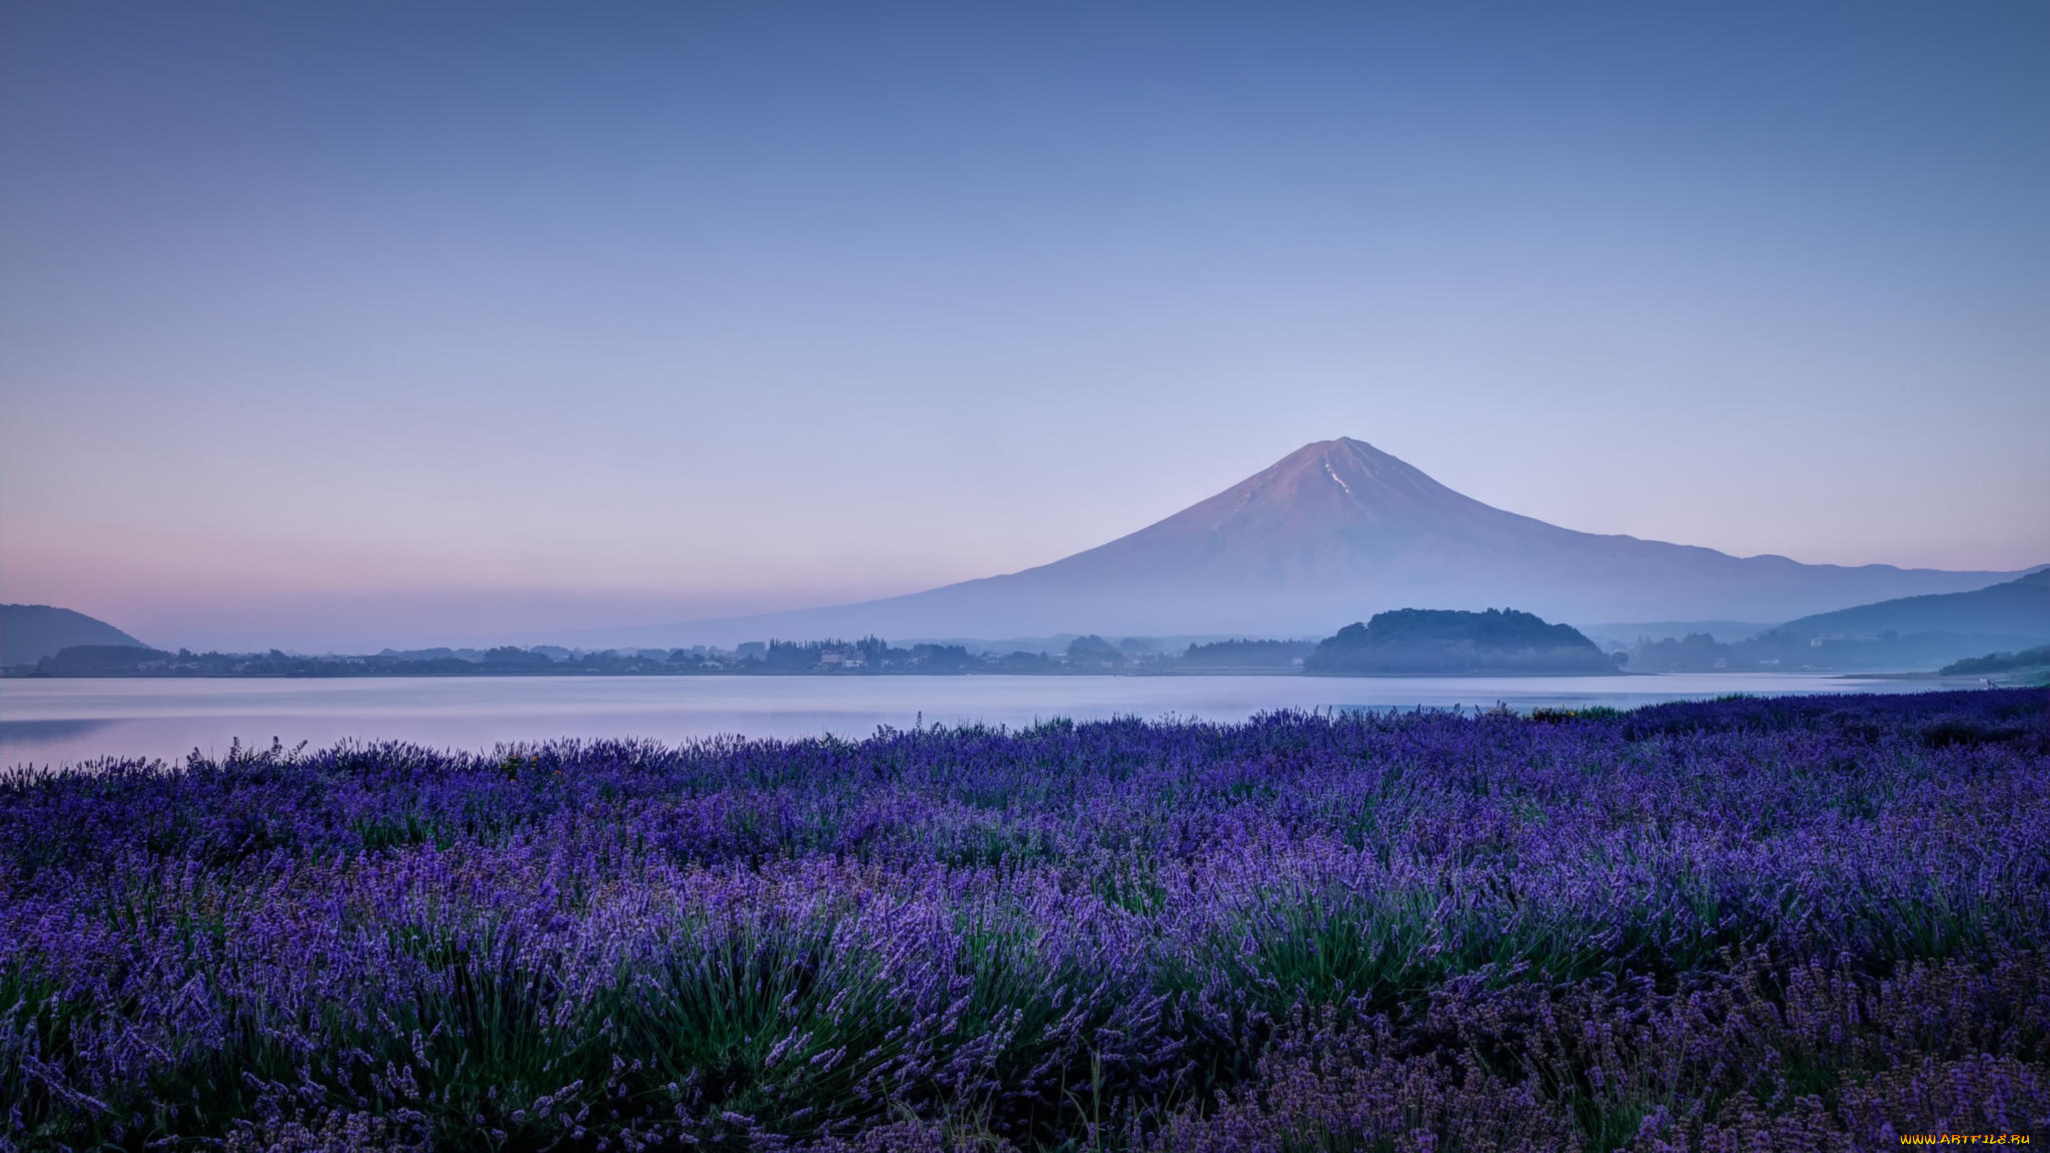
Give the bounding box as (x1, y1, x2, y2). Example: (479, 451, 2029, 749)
(1304, 609, 1615, 675)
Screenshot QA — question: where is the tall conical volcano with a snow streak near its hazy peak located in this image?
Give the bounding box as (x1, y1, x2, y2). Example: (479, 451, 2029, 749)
(642, 439, 2015, 644)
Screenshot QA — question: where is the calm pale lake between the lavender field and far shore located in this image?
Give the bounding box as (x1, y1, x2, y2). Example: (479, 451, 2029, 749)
(0, 673, 1935, 767)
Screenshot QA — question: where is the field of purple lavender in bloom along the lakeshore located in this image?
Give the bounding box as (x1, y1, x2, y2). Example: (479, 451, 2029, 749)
(0, 691, 2050, 1151)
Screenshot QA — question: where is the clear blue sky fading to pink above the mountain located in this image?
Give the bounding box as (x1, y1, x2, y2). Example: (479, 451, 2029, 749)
(0, 0, 2050, 646)
